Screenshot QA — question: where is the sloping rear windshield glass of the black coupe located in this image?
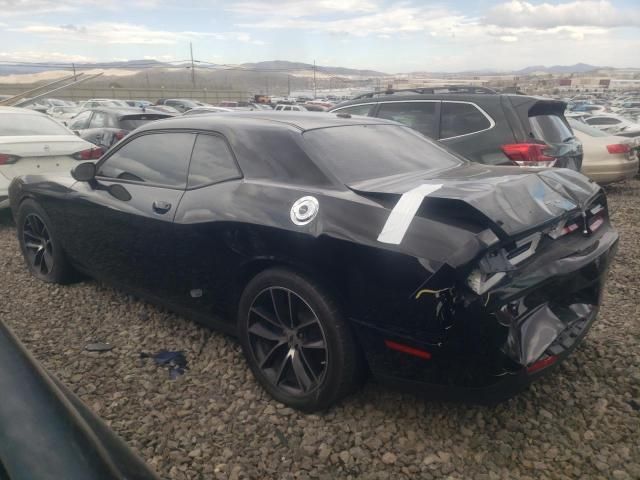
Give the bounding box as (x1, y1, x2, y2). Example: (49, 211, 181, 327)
(303, 125, 463, 184)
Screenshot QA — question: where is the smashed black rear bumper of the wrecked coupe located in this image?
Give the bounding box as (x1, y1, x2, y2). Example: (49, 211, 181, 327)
(358, 228, 618, 403)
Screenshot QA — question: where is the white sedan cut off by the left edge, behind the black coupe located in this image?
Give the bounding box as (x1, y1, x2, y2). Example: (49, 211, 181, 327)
(0, 107, 103, 208)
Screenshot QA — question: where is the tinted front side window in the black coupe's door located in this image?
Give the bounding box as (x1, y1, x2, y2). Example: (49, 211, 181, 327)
(98, 133, 195, 188)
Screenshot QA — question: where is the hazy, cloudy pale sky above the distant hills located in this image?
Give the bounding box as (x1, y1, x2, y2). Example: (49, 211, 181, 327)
(0, 0, 640, 72)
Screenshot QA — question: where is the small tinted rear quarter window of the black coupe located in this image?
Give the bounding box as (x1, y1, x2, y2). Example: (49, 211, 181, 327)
(187, 134, 240, 188)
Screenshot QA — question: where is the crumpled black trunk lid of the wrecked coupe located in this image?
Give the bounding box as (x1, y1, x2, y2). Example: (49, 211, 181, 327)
(348, 163, 600, 236)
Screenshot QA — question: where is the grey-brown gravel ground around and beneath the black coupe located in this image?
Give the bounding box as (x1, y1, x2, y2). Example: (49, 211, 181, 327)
(0, 180, 640, 480)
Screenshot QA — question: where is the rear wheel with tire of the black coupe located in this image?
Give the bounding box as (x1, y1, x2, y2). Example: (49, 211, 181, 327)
(238, 269, 364, 412)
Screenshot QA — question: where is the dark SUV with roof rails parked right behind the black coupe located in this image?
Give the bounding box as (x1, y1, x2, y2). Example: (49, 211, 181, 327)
(331, 86, 582, 170)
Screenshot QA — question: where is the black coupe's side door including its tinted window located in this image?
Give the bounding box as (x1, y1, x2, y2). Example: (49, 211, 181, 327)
(65, 131, 195, 297)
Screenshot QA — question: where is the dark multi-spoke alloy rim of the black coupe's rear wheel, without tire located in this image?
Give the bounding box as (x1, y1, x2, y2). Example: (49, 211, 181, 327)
(248, 287, 329, 396)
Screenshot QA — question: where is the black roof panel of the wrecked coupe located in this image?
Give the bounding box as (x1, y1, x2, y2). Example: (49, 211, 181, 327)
(138, 111, 399, 131)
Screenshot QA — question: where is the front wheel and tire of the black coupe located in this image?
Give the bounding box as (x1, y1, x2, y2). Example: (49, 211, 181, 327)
(16, 200, 74, 284)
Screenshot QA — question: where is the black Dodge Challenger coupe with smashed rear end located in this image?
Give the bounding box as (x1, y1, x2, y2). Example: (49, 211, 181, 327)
(10, 112, 618, 411)
